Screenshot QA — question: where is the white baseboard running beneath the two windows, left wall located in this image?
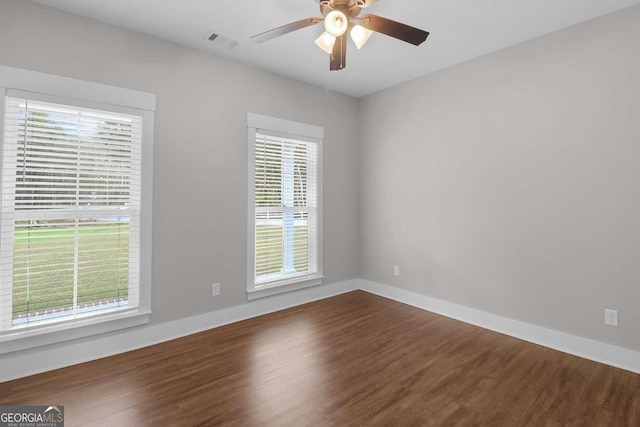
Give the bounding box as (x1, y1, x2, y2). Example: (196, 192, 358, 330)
(0, 280, 358, 382)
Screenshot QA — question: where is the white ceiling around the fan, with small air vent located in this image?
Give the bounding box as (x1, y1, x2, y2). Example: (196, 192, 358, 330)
(25, 0, 640, 97)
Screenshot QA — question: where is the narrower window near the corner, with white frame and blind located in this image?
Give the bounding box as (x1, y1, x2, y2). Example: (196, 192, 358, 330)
(247, 114, 324, 298)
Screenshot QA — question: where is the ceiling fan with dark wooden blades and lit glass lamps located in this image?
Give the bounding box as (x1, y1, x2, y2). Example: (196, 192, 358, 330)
(251, 0, 429, 71)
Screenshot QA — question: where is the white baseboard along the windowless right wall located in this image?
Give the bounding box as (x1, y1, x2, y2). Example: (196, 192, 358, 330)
(358, 279, 640, 374)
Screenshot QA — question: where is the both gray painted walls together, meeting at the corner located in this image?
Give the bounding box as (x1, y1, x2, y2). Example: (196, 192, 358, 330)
(0, 0, 640, 362)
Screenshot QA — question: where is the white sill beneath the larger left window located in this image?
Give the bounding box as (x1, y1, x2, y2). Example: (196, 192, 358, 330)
(0, 311, 151, 355)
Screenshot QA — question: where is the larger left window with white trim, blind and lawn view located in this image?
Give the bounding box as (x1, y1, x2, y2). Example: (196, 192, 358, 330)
(0, 67, 152, 351)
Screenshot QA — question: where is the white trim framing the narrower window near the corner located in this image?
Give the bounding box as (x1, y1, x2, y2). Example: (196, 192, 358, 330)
(247, 113, 324, 300)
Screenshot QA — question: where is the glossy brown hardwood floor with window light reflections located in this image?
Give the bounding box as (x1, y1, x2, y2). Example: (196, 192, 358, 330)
(0, 291, 640, 426)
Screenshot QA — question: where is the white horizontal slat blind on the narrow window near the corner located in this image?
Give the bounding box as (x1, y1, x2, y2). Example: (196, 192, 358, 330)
(254, 132, 318, 287)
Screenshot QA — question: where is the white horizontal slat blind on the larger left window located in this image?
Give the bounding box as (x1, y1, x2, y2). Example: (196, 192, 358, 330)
(0, 97, 142, 330)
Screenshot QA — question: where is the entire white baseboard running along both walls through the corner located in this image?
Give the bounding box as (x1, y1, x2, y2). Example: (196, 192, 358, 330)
(0, 279, 640, 382)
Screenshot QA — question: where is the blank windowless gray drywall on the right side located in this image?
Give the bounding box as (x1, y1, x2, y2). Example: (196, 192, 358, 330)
(360, 7, 640, 350)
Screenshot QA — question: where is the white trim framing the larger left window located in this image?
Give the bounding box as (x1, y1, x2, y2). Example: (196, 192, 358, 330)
(0, 65, 156, 354)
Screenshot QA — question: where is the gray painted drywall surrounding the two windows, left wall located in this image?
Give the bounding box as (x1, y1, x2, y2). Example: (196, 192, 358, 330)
(0, 0, 359, 361)
